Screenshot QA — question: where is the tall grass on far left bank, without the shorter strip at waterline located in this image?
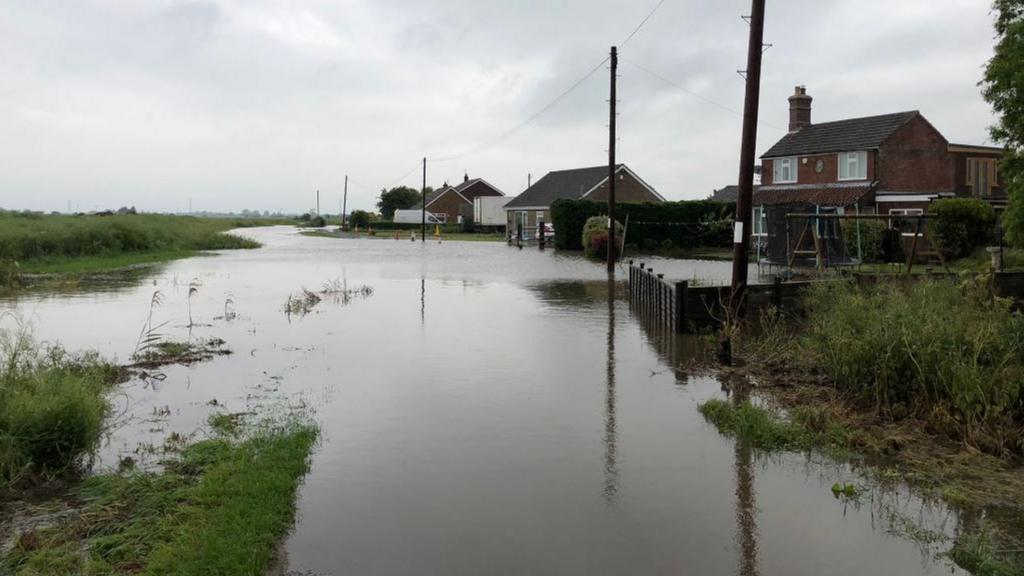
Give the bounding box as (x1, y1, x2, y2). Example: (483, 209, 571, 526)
(0, 212, 259, 262)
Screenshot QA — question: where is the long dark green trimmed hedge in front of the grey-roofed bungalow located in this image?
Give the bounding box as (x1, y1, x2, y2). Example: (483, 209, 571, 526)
(551, 200, 736, 250)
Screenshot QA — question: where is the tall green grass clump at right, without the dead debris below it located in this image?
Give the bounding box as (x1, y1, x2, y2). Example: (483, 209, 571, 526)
(800, 280, 1024, 455)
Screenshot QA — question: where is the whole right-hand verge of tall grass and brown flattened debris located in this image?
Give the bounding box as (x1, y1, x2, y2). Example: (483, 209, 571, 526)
(716, 277, 1024, 575)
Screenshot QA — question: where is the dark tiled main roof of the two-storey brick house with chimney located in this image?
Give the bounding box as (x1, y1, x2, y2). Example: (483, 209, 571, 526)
(762, 111, 921, 158)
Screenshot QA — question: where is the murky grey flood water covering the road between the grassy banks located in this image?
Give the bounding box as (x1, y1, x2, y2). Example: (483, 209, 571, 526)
(0, 228, 957, 576)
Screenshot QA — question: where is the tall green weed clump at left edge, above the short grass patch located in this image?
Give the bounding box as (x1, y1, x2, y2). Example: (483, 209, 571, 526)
(0, 332, 122, 489)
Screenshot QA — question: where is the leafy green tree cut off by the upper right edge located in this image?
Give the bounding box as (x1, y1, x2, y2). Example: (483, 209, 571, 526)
(981, 0, 1024, 245)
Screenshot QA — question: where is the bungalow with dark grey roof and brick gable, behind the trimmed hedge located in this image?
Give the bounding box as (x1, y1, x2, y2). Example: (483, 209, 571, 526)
(505, 164, 665, 233)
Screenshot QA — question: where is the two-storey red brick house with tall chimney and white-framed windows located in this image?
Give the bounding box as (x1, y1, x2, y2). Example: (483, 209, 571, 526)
(752, 86, 1006, 253)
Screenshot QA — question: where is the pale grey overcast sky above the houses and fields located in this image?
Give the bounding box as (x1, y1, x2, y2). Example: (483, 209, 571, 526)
(0, 0, 993, 211)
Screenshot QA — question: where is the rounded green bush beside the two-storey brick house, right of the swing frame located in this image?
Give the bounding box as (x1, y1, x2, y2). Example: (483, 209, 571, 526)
(929, 198, 995, 258)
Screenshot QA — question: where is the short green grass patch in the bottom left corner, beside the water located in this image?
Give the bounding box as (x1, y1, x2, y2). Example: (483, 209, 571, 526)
(0, 424, 317, 576)
